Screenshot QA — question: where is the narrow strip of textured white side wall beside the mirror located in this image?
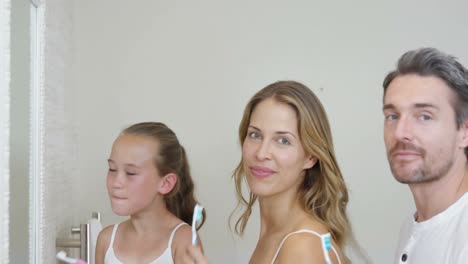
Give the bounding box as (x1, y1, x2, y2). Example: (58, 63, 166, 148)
(34, 0, 77, 263)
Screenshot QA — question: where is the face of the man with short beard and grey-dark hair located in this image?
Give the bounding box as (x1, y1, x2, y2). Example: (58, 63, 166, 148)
(383, 74, 466, 184)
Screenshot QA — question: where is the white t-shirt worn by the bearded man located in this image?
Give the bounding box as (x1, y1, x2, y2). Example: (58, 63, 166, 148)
(394, 193, 468, 264)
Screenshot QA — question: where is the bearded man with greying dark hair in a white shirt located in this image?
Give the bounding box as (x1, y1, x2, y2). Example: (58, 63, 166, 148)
(383, 48, 468, 264)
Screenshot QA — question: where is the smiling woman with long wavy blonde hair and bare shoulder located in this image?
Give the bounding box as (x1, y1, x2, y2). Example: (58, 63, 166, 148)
(186, 81, 352, 263)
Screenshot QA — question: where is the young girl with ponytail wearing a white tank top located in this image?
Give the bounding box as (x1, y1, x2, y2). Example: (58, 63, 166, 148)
(96, 122, 203, 264)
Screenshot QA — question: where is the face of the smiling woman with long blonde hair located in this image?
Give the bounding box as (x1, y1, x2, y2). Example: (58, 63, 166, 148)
(242, 98, 316, 197)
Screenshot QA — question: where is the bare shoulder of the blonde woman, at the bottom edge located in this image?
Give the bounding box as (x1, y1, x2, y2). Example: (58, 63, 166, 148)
(277, 232, 338, 263)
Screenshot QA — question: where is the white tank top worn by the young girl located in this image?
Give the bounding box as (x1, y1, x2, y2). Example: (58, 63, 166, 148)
(104, 223, 186, 264)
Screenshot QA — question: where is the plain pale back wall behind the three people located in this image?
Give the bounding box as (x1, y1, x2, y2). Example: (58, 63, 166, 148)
(66, 0, 468, 263)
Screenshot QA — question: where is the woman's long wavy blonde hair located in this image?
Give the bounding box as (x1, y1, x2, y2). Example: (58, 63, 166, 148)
(233, 81, 351, 247)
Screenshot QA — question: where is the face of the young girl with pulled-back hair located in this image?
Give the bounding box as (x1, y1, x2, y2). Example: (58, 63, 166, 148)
(107, 135, 162, 216)
